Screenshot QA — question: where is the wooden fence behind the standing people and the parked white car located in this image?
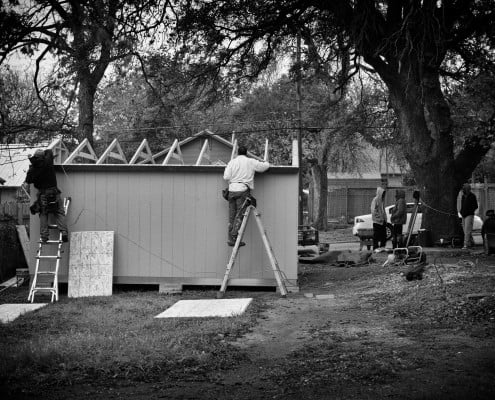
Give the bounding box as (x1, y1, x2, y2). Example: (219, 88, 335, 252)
(327, 183, 495, 223)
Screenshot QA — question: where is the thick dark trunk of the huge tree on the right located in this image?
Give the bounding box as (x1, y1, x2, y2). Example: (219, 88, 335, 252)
(389, 70, 462, 241)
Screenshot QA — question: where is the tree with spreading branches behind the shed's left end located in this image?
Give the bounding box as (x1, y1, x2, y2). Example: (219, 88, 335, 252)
(0, 0, 169, 142)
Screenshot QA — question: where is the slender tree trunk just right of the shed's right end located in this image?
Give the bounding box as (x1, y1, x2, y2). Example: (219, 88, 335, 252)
(311, 163, 328, 231)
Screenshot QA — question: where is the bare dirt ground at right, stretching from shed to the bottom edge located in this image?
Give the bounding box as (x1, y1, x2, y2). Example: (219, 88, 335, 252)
(3, 255, 495, 400)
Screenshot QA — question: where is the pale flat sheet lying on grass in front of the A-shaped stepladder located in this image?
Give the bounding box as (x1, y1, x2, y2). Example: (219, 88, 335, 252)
(155, 298, 253, 318)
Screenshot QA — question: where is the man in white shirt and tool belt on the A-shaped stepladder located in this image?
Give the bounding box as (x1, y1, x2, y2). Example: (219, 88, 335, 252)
(223, 146, 270, 247)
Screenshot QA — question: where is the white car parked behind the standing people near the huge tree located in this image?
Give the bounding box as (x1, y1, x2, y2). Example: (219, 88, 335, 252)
(352, 203, 483, 240)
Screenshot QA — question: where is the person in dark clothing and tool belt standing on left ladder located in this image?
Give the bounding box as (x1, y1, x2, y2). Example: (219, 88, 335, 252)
(25, 149, 68, 242)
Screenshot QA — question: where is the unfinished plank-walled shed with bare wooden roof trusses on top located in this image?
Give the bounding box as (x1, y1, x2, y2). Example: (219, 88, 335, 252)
(30, 131, 298, 290)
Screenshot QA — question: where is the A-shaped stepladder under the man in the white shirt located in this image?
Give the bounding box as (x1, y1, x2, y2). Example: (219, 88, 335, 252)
(217, 199, 287, 299)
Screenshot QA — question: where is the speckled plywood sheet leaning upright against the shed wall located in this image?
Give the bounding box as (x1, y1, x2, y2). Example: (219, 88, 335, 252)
(67, 231, 114, 297)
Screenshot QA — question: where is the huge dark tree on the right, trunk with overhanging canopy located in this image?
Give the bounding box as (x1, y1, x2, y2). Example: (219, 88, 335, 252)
(176, 0, 495, 241)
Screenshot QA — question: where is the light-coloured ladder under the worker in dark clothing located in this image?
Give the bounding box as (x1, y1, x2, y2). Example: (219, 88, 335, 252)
(28, 197, 71, 303)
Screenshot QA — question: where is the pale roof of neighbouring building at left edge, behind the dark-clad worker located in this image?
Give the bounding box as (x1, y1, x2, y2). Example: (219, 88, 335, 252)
(0, 143, 45, 187)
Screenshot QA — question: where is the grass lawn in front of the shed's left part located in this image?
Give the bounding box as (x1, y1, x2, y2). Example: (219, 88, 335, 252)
(0, 289, 263, 384)
